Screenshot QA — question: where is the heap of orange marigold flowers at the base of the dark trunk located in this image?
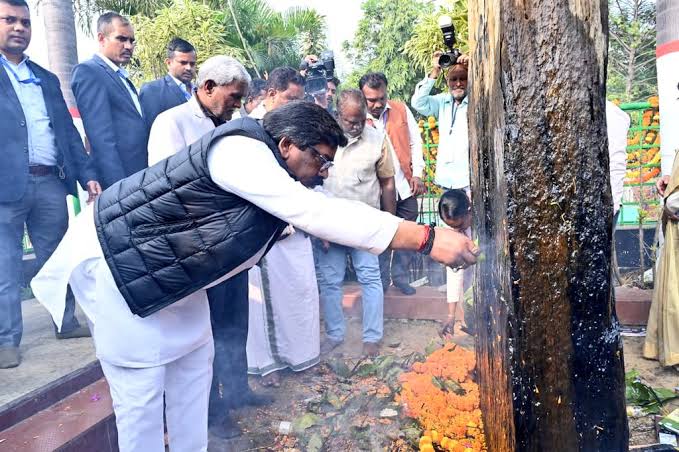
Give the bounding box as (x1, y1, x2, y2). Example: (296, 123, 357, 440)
(397, 343, 486, 452)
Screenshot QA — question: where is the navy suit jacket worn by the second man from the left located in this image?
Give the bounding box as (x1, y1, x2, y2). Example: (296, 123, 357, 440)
(71, 55, 148, 189)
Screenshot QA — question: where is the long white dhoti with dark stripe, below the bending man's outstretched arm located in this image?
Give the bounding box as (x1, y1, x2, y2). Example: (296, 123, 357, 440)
(247, 231, 320, 375)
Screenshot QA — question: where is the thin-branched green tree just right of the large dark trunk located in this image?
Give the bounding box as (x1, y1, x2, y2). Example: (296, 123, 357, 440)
(607, 0, 658, 102)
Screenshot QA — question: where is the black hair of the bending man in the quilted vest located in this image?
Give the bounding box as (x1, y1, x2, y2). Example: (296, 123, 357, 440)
(263, 100, 347, 149)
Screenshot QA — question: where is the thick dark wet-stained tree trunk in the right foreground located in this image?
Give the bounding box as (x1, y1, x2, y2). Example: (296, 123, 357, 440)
(469, 0, 628, 452)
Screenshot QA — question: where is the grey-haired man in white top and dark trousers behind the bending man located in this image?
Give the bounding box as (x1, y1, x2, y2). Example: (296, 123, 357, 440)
(149, 56, 262, 438)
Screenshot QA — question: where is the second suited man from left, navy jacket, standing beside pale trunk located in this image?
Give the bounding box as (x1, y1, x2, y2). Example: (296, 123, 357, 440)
(71, 13, 148, 189)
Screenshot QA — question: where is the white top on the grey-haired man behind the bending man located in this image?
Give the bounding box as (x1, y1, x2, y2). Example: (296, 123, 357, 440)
(149, 96, 215, 165)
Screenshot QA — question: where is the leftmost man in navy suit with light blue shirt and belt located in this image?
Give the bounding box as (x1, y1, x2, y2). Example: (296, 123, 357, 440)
(0, 0, 101, 369)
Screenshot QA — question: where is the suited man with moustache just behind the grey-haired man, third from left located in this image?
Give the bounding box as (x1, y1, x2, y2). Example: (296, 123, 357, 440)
(139, 38, 196, 130)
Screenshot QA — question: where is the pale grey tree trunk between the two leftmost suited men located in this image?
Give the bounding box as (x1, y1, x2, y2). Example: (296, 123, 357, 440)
(40, 0, 78, 108)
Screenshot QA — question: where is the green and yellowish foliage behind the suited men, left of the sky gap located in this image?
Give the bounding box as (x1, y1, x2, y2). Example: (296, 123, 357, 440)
(74, 0, 326, 80)
